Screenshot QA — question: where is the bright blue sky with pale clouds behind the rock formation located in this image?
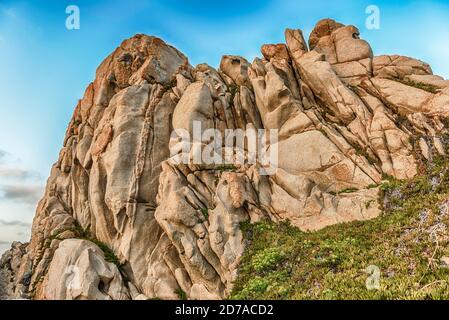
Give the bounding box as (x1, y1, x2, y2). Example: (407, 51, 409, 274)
(0, 0, 449, 251)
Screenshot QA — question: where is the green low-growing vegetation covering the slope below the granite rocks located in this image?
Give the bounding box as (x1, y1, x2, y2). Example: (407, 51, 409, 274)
(230, 158, 449, 299)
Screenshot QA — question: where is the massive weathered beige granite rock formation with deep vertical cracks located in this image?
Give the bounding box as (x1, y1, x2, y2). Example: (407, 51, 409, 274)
(0, 20, 449, 299)
